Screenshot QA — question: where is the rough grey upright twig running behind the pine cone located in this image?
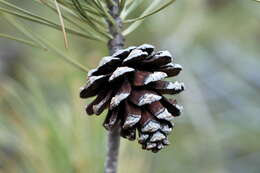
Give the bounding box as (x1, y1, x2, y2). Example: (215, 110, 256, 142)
(104, 0, 124, 173)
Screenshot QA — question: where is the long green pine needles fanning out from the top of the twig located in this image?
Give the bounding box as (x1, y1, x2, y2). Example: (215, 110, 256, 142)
(0, 0, 177, 72)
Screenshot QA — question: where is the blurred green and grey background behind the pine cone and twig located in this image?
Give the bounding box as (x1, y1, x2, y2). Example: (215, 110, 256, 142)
(0, 0, 260, 173)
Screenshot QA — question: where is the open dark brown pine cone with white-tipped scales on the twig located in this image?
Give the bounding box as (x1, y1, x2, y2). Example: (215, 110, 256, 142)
(80, 44, 184, 152)
